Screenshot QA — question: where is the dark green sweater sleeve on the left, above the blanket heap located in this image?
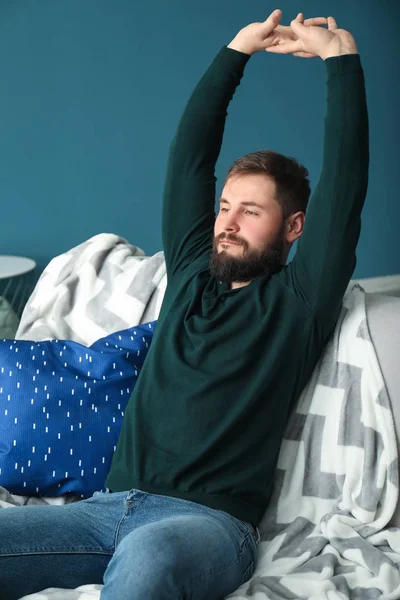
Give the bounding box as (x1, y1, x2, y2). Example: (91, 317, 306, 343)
(162, 46, 250, 275)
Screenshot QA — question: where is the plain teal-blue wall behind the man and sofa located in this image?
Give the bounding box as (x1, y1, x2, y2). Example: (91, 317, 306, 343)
(0, 0, 400, 277)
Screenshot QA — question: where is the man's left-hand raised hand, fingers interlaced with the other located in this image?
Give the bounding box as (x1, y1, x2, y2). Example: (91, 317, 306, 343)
(228, 9, 327, 58)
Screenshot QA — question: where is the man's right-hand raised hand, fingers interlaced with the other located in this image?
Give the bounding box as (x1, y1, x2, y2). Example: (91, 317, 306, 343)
(265, 13, 357, 60)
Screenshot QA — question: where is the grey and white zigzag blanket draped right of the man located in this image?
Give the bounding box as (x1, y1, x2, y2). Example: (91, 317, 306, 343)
(229, 285, 400, 600)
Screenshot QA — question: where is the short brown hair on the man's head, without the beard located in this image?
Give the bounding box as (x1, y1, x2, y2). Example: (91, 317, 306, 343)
(226, 150, 310, 219)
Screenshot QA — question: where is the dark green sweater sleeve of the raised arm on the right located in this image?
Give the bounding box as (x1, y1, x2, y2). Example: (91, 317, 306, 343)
(286, 54, 369, 330)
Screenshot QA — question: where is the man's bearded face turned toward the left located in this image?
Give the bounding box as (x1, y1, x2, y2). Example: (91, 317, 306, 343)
(210, 174, 284, 283)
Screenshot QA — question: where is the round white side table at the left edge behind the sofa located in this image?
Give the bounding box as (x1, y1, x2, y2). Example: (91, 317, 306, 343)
(0, 255, 36, 339)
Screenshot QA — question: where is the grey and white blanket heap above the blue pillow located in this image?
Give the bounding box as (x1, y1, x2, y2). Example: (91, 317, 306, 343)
(15, 233, 167, 346)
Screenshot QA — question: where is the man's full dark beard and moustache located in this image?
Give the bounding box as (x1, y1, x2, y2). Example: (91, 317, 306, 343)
(209, 228, 284, 283)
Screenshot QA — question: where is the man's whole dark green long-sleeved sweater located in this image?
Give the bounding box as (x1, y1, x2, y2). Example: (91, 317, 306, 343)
(107, 47, 368, 525)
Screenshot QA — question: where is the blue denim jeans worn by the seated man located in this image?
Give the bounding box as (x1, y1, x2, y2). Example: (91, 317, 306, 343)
(0, 489, 259, 600)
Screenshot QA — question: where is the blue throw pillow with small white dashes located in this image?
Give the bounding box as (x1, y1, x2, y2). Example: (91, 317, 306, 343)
(0, 321, 156, 497)
